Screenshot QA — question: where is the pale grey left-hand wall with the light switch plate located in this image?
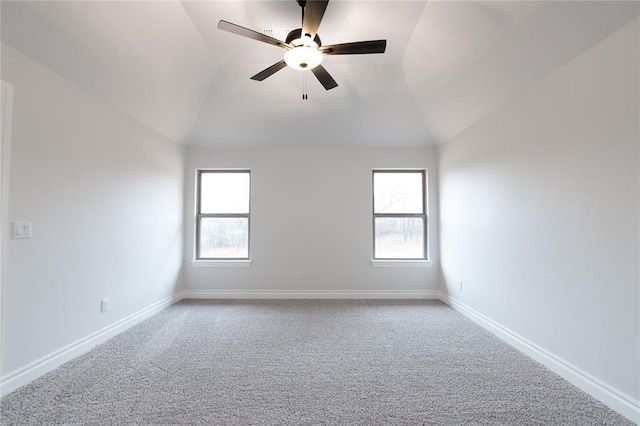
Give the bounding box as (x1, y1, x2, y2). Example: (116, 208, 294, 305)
(2, 44, 184, 377)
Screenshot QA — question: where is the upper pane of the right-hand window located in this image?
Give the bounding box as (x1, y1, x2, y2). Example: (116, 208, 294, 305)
(373, 172, 424, 214)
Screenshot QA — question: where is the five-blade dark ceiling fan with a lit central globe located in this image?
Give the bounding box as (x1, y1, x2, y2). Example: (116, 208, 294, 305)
(218, 0, 387, 92)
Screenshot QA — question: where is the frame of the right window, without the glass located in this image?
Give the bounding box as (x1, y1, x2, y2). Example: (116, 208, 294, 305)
(371, 169, 429, 265)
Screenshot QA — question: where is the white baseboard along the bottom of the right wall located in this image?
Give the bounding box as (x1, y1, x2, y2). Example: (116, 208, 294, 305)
(440, 293, 640, 424)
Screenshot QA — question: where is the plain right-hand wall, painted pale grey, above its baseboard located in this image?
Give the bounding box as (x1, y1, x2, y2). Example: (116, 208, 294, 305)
(439, 20, 640, 404)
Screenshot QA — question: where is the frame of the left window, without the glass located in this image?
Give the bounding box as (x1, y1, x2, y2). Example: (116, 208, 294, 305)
(194, 169, 252, 263)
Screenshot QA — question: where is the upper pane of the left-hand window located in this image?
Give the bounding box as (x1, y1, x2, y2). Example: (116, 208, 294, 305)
(200, 172, 251, 213)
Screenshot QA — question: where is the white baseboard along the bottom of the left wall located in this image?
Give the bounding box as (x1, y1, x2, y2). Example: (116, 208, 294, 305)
(0, 292, 182, 396)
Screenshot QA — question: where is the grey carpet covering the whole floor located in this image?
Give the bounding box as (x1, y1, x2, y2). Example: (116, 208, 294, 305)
(0, 300, 631, 425)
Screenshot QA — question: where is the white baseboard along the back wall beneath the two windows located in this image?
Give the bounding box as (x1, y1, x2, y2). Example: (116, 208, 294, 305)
(182, 290, 440, 299)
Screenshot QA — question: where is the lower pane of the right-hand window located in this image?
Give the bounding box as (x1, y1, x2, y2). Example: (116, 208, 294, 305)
(375, 217, 425, 259)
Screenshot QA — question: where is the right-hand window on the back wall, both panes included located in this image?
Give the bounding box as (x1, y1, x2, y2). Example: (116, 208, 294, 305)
(373, 170, 427, 260)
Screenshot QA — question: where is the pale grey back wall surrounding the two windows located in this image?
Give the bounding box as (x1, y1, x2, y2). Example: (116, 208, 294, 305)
(184, 146, 438, 297)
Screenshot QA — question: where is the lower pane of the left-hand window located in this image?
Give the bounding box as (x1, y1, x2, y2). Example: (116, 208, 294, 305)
(199, 217, 249, 259)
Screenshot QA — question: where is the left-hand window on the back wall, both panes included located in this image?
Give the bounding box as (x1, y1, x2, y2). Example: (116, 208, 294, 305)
(196, 170, 251, 260)
